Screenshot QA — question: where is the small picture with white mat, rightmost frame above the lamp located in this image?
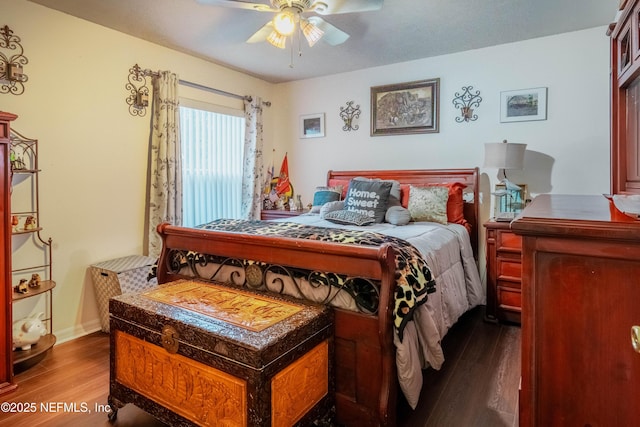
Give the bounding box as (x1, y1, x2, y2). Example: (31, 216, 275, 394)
(500, 87, 547, 123)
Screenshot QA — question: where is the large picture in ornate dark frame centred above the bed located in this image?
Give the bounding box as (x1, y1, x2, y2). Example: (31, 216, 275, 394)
(371, 79, 440, 136)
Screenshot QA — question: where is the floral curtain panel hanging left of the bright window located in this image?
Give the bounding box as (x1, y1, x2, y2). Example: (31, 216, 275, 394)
(145, 71, 182, 257)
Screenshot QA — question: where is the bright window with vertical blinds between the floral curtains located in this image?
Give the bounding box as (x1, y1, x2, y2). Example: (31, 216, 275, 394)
(180, 100, 244, 227)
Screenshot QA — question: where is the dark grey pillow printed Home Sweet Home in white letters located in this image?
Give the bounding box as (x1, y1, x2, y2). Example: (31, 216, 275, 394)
(344, 179, 391, 223)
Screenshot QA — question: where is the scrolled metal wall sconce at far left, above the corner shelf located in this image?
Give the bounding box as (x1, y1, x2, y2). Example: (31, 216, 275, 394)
(0, 25, 29, 95)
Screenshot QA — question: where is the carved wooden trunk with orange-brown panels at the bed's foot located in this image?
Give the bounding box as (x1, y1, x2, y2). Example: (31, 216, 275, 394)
(109, 280, 334, 426)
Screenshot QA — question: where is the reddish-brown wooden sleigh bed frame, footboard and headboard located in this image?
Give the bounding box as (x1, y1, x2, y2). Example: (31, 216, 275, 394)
(157, 168, 479, 426)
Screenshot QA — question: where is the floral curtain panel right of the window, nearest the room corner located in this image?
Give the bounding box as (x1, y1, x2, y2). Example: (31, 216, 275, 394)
(240, 96, 264, 219)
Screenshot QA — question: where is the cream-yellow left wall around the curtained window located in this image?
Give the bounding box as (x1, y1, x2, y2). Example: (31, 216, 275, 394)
(0, 0, 273, 341)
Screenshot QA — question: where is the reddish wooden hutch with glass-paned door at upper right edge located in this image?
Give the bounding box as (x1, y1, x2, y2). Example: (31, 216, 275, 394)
(609, 0, 640, 194)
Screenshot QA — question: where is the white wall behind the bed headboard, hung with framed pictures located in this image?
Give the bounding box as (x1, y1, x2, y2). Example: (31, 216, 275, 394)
(274, 27, 609, 219)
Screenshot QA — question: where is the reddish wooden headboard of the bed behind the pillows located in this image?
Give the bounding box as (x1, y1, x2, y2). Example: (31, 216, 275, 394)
(327, 168, 480, 259)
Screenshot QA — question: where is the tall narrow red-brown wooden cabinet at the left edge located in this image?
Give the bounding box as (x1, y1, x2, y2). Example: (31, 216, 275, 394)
(0, 111, 17, 394)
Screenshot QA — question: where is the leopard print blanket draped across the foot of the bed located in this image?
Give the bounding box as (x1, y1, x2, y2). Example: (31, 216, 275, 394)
(198, 219, 436, 340)
